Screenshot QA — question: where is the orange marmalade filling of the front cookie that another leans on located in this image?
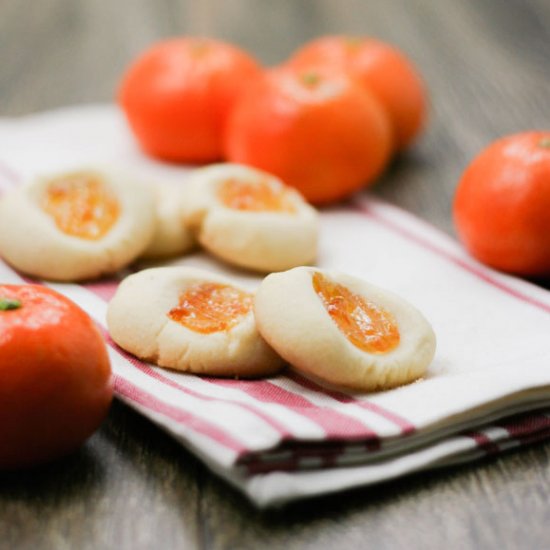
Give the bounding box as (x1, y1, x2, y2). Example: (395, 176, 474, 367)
(168, 283, 253, 334)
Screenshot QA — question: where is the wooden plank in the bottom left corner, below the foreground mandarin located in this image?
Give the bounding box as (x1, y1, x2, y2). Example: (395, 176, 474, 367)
(0, 402, 206, 549)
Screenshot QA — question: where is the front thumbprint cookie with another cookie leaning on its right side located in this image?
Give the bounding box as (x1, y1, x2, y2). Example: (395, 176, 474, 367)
(107, 266, 283, 377)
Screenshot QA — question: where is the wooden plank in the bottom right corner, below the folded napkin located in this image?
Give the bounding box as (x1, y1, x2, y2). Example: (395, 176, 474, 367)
(201, 445, 550, 550)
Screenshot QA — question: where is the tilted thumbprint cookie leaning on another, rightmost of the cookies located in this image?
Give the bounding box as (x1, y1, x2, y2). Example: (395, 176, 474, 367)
(254, 267, 435, 391)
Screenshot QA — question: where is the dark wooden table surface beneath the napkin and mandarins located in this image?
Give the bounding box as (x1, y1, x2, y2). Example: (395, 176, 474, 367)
(0, 0, 550, 549)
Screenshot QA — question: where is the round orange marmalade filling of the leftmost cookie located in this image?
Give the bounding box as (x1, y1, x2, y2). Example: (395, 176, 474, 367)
(42, 173, 120, 241)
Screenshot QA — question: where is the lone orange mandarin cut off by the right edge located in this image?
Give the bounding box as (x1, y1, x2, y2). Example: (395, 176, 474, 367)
(453, 131, 550, 277)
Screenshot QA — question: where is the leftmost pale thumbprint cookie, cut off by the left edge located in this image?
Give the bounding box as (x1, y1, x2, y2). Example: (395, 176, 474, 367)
(0, 169, 154, 281)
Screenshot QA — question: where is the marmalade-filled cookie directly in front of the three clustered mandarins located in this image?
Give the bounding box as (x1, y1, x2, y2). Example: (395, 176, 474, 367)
(183, 164, 318, 271)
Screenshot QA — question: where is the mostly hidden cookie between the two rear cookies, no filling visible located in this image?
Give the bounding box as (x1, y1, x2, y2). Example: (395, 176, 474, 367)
(141, 185, 195, 259)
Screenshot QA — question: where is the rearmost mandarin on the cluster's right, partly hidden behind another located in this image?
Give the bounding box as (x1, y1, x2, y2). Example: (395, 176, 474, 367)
(288, 36, 427, 150)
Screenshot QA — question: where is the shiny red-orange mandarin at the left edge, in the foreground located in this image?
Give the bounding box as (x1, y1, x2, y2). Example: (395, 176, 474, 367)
(0, 285, 113, 469)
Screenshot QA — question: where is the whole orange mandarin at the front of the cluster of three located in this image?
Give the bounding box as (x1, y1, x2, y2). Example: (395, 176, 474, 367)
(225, 68, 391, 204)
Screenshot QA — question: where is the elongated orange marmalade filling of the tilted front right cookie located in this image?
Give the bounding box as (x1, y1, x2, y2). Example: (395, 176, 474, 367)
(313, 272, 400, 354)
